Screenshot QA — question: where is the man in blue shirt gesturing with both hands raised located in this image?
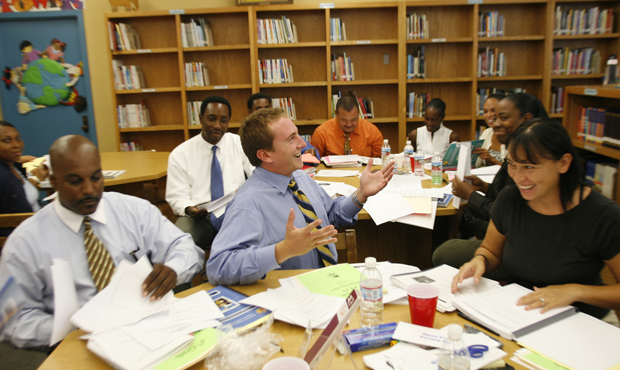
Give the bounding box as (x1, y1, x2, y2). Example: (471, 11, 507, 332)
(207, 109, 393, 285)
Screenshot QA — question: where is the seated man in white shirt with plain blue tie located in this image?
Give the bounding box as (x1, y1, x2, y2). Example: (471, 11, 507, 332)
(166, 96, 254, 250)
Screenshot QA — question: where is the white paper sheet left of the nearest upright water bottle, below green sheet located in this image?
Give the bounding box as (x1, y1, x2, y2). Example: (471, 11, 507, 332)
(240, 287, 344, 329)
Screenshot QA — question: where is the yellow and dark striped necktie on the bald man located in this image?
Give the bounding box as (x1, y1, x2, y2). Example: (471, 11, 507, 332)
(84, 217, 116, 291)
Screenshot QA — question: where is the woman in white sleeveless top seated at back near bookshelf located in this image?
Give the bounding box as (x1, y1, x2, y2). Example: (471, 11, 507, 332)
(409, 98, 459, 158)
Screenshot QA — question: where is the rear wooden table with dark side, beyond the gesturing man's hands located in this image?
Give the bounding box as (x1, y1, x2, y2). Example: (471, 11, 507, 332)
(315, 164, 458, 269)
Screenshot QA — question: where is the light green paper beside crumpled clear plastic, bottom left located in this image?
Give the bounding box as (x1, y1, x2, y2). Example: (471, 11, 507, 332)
(153, 328, 217, 370)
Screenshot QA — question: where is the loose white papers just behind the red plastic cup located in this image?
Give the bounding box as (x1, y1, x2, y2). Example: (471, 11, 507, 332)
(391, 265, 500, 312)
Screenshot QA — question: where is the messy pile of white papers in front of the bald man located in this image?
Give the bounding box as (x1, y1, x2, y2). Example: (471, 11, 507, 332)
(71, 258, 224, 369)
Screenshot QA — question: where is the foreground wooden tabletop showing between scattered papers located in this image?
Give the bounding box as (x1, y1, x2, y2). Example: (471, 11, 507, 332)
(39, 270, 523, 370)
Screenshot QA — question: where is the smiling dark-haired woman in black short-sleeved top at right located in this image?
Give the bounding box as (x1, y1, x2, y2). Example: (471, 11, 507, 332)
(452, 118, 620, 318)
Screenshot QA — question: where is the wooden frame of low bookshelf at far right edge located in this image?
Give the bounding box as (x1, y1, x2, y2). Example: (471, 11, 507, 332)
(563, 85, 620, 203)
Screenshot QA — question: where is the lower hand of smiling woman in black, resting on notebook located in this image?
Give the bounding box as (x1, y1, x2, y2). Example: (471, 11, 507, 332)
(517, 284, 584, 313)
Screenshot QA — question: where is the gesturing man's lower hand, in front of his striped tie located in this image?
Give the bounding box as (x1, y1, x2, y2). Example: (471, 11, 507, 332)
(275, 208, 338, 264)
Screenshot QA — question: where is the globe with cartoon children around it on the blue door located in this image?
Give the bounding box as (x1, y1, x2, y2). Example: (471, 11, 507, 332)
(3, 39, 86, 114)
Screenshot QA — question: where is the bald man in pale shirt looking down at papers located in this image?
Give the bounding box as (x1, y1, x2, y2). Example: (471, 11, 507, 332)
(0, 135, 204, 349)
